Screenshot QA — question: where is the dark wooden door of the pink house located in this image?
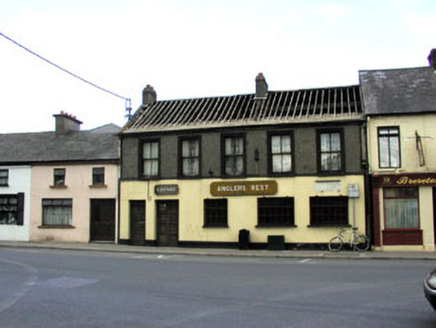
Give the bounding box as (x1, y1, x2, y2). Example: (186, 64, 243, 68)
(91, 199, 115, 242)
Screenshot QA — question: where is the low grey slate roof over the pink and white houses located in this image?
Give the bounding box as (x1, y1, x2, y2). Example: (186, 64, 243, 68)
(0, 128, 119, 165)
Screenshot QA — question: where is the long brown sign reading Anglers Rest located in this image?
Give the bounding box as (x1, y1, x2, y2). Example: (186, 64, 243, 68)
(210, 180, 277, 196)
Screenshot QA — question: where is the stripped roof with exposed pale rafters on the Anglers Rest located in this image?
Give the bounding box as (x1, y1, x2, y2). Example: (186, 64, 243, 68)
(122, 85, 362, 133)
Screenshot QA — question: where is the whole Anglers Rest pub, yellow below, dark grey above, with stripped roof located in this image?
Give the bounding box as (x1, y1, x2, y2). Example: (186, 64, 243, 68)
(118, 73, 367, 249)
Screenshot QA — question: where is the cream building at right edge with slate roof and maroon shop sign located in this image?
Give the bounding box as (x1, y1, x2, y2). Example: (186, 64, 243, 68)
(360, 49, 436, 251)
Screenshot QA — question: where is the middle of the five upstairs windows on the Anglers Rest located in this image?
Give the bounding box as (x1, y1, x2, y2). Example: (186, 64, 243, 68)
(223, 136, 245, 177)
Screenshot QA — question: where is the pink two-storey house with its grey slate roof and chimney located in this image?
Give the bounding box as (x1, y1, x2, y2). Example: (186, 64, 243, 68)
(0, 112, 119, 243)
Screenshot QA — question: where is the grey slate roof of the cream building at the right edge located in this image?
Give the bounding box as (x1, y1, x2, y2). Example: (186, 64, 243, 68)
(359, 67, 436, 115)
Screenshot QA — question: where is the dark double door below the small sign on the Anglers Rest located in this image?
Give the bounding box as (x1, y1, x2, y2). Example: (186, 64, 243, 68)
(156, 200, 179, 247)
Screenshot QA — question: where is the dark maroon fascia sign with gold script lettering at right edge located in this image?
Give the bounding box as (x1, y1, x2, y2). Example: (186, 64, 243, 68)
(373, 173, 436, 188)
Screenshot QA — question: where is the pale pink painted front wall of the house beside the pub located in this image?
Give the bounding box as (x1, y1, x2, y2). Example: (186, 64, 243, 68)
(30, 163, 118, 243)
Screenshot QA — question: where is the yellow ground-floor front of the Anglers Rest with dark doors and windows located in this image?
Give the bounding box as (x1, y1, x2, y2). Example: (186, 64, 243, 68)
(120, 175, 367, 249)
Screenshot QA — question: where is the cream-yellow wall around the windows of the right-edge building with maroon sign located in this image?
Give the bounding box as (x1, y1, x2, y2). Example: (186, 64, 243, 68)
(367, 114, 436, 251)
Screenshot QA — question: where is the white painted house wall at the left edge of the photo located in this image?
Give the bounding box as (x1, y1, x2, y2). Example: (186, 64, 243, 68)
(0, 166, 31, 241)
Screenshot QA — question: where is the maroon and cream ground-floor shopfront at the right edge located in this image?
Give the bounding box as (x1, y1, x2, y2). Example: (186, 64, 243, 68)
(372, 173, 436, 251)
